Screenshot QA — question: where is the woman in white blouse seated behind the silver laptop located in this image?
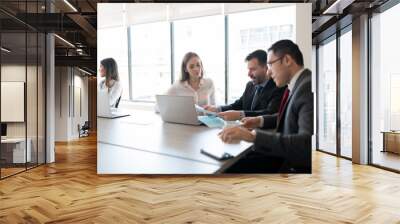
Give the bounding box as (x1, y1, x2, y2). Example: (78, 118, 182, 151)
(167, 52, 215, 106)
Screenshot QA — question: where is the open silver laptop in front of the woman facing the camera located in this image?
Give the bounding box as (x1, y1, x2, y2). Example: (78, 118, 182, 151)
(156, 95, 224, 126)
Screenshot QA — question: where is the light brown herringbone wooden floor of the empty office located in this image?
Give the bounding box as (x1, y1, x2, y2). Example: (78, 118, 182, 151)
(0, 134, 400, 224)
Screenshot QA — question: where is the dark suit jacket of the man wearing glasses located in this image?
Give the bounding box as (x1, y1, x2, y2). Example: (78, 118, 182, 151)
(254, 69, 314, 172)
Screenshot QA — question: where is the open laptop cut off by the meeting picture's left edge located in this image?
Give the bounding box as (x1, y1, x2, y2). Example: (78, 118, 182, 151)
(97, 89, 129, 118)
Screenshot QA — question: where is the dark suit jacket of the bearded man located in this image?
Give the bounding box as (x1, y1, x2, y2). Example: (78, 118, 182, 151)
(221, 79, 286, 117)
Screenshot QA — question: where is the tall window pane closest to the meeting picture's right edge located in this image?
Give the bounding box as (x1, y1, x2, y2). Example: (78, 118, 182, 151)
(318, 37, 337, 153)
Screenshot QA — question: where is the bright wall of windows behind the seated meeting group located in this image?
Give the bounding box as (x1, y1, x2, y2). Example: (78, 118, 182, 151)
(98, 4, 296, 105)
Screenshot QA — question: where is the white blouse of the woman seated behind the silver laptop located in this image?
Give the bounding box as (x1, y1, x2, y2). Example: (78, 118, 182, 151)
(167, 78, 215, 106)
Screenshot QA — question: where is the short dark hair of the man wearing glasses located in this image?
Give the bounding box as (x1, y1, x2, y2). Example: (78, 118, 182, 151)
(268, 40, 304, 66)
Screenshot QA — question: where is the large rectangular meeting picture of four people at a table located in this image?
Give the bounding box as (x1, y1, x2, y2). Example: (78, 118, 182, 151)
(97, 3, 314, 174)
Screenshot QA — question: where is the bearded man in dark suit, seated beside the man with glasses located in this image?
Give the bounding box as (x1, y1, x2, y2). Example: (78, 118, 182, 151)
(204, 50, 286, 120)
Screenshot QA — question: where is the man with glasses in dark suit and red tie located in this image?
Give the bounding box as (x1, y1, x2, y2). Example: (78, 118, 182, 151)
(220, 40, 314, 173)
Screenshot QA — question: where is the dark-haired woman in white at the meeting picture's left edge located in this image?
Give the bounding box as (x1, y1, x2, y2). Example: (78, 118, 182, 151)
(99, 58, 122, 108)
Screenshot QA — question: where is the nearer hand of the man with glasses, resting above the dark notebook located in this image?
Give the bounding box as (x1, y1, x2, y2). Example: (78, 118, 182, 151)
(218, 126, 256, 143)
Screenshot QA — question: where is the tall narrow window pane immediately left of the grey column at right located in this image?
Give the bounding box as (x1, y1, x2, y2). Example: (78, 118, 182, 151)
(340, 29, 353, 158)
